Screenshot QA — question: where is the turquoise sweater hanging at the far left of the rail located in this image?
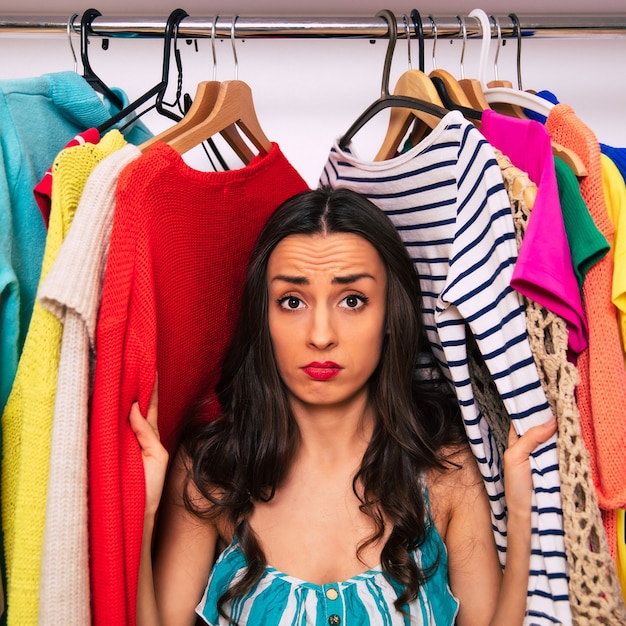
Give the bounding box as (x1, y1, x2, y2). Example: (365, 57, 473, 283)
(0, 72, 151, 414)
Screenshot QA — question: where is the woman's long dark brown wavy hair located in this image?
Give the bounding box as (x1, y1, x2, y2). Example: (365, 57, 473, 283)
(184, 188, 467, 623)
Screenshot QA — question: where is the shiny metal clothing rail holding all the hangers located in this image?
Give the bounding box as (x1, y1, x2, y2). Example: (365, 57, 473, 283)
(0, 13, 626, 39)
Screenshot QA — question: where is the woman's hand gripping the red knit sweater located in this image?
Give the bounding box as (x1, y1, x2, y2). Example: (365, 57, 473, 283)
(129, 380, 169, 516)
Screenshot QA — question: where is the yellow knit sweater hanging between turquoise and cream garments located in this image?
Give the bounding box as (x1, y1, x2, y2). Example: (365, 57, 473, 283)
(2, 132, 125, 626)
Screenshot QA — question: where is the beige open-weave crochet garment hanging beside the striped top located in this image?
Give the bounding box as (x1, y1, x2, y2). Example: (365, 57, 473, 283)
(497, 153, 626, 626)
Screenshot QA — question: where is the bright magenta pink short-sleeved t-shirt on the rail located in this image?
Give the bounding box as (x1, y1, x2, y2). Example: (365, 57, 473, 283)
(480, 110, 588, 354)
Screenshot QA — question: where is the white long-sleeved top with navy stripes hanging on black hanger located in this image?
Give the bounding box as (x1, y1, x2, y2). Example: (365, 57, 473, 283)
(320, 111, 572, 625)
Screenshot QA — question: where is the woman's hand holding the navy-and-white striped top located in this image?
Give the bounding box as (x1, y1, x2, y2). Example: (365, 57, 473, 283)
(504, 418, 556, 518)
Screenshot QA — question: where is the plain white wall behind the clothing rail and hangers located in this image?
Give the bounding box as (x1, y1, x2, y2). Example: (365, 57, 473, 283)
(0, 0, 626, 185)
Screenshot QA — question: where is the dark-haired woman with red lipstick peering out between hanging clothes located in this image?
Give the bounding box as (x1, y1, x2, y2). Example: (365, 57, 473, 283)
(130, 189, 556, 626)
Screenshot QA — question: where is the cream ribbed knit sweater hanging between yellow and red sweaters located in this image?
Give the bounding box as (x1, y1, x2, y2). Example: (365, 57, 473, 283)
(39, 141, 141, 626)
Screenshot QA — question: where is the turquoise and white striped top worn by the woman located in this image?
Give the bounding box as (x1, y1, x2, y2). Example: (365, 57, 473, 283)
(196, 522, 459, 626)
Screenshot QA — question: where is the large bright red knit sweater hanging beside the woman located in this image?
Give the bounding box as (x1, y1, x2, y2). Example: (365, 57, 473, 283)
(89, 144, 307, 626)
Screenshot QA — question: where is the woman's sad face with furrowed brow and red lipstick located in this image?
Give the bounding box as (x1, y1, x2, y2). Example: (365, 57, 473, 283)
(267, 233, 387, 410)
